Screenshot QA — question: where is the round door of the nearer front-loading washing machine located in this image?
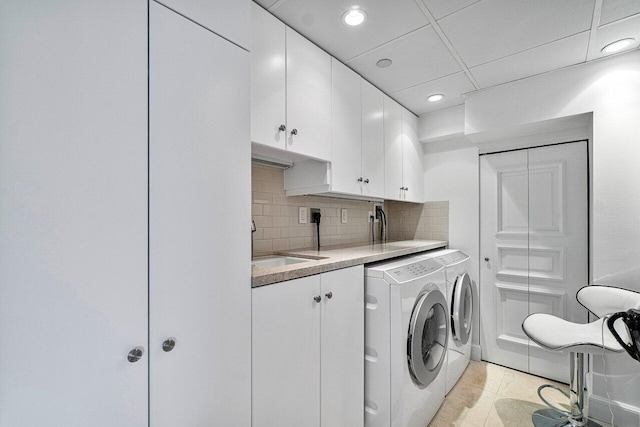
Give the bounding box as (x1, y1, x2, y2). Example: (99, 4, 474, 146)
(407, 289, 449, 388)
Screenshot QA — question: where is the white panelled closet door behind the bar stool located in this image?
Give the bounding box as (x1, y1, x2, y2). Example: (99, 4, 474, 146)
(480, 142, 588, 381)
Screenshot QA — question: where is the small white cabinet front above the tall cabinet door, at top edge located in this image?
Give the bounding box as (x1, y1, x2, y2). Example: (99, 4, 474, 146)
(159, 0, 253, 49)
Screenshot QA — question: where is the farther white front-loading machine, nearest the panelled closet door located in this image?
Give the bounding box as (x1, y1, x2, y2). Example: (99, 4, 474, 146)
(424, 249, 473, 393)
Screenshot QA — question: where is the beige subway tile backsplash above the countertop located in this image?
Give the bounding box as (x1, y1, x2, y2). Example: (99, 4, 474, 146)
(251, 164, 449, 256)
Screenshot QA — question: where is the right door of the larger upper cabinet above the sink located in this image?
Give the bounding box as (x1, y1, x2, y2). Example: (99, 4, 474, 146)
(286, 27, 331, 161)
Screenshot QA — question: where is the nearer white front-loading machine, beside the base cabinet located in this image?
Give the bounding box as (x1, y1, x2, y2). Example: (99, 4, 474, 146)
(365, 256, 449, 427)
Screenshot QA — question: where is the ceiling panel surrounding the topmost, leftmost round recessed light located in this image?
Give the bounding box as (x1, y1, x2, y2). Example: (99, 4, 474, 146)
(262, 0, 429, 62)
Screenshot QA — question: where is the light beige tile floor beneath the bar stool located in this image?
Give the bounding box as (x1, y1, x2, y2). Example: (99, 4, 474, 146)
(429, 360, 608, 427)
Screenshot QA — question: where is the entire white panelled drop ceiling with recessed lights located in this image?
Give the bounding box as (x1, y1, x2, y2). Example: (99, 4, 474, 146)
(256, 0, 640, 114)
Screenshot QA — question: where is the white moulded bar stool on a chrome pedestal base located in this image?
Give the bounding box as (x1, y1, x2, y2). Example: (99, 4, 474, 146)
(522, 285, 640, 427)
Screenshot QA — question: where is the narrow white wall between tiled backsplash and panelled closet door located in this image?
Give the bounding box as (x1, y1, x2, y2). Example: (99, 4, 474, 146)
(423, 137, 480, 360)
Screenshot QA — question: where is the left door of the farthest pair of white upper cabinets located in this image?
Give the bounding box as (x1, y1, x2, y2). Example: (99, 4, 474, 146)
(384, 95, 404, 200)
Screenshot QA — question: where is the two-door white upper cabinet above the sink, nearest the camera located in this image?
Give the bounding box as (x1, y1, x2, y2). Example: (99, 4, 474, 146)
(251, 3, 331, 161)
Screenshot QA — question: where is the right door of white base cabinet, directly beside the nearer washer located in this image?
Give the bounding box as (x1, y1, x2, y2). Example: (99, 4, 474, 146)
(320, 265, 364, 427)
